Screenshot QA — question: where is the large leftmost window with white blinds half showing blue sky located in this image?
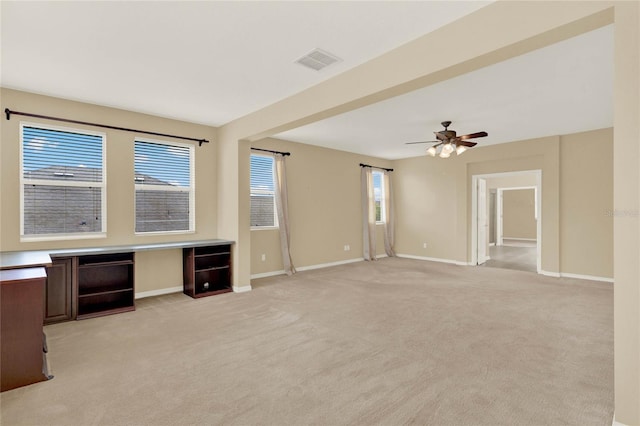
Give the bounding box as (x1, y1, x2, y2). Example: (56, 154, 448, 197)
(20, 123, 106, 240)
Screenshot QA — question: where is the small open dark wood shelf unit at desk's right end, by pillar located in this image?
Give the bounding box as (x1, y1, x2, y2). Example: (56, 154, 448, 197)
(183, 244, 232, 297)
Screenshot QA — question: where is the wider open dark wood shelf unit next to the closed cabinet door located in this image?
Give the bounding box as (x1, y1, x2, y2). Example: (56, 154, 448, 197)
(77, 253, 135, 319)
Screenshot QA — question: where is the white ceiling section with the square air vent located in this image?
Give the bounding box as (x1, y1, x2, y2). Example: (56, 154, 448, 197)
(1, 1, 489, 126)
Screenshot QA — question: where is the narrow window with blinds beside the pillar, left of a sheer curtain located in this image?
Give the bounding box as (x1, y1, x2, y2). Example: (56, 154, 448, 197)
(251, 154, 278, 228)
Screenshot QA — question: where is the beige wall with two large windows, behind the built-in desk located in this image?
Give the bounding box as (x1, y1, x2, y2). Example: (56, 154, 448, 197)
(0, 88, 217, 292)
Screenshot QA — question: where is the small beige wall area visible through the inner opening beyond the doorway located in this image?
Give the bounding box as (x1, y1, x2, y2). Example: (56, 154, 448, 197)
(502, 189, 538, 240)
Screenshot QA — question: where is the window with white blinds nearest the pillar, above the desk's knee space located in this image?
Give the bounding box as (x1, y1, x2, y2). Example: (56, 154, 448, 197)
(134, 139, 195, 233)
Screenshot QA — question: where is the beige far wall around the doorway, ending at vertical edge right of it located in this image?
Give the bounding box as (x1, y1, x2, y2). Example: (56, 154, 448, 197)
(394, 137, 560, 273)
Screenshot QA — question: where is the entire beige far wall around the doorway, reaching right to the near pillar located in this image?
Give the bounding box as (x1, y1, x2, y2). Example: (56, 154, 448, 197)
(392, 129, 613, 278)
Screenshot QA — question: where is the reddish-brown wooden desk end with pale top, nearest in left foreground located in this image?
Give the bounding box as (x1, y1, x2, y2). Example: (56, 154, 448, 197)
(0, 267, 50, 391)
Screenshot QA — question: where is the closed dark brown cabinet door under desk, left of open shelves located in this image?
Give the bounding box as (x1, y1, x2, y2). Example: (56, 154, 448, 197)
(44, 258, 72, 324)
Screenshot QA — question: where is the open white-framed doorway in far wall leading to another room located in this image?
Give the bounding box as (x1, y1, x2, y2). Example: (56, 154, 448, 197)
(471, 170, 542, 273)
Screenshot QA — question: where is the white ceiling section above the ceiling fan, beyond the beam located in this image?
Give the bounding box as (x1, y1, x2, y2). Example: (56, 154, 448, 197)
(275, 25, 613, 159)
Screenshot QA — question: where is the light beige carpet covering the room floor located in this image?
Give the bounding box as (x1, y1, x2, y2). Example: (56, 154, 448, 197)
(1, 259, 613, 426)
